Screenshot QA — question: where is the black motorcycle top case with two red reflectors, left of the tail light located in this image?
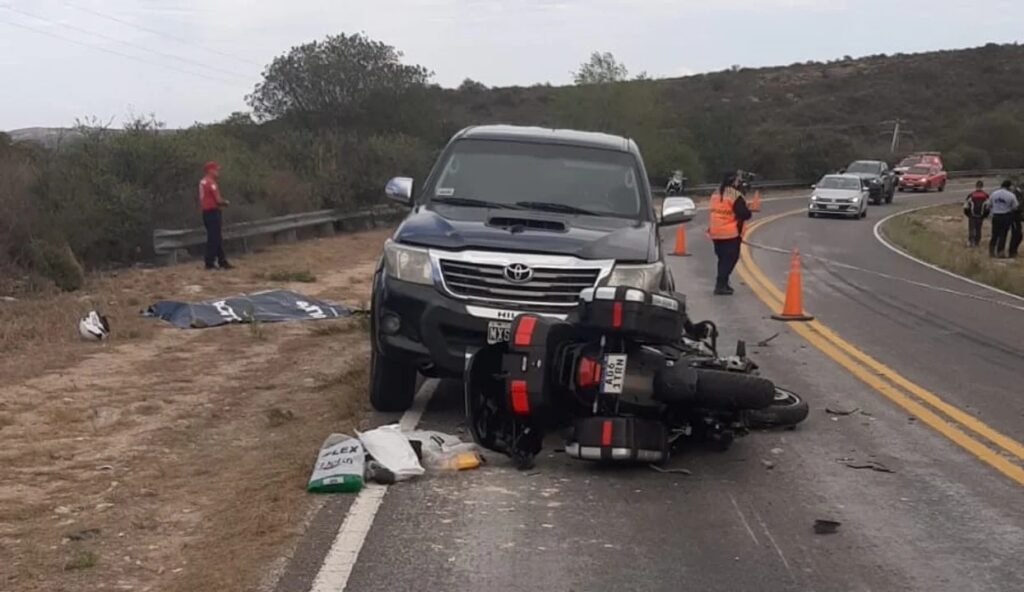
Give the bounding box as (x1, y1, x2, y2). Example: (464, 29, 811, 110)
(502, 314, 574, 417)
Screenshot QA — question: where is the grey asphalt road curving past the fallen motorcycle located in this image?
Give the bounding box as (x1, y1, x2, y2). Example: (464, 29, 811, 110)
(279, 185, 1024, 592)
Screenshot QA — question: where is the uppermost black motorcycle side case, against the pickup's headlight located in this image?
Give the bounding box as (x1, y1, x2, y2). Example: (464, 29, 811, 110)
(579, 287, 683, 343)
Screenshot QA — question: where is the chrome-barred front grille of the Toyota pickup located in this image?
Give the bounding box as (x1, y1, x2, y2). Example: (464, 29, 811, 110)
(440, 259, 601, 306)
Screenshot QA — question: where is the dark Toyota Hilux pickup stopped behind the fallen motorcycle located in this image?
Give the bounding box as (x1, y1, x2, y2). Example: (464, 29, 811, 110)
(370, 126, 694, 412)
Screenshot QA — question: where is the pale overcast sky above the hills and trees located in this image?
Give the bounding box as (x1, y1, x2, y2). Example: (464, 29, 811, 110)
(0, 0, 1024, 129)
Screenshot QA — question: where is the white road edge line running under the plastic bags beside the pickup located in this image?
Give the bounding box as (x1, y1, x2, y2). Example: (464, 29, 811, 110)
(309, 380, 438, 592)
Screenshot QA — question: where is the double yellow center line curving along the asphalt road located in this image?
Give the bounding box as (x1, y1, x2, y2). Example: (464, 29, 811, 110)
(739, 209, 1024, 485)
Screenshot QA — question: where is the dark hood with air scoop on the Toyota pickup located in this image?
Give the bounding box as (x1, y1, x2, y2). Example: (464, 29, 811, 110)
(394, 205, 657, 262)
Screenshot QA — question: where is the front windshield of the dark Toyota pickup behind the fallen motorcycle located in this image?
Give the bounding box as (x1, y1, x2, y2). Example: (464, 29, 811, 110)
(426, 139, 644, 218)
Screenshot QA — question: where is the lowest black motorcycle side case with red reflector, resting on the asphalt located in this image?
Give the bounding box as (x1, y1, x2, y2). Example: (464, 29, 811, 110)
(565, 417, 669, 463)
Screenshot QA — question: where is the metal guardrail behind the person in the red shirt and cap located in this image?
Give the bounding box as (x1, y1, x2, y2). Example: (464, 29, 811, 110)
(153, 206, 408, 264)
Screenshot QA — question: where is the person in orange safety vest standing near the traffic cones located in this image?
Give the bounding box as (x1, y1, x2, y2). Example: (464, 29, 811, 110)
(708, 172, 753, 296)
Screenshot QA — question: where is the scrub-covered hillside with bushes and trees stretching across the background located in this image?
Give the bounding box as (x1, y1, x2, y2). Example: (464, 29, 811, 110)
(0, 41, 1024, 276)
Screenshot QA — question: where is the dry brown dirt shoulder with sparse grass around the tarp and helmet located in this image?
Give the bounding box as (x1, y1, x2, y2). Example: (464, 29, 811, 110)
(0, 231, 387, 592)
